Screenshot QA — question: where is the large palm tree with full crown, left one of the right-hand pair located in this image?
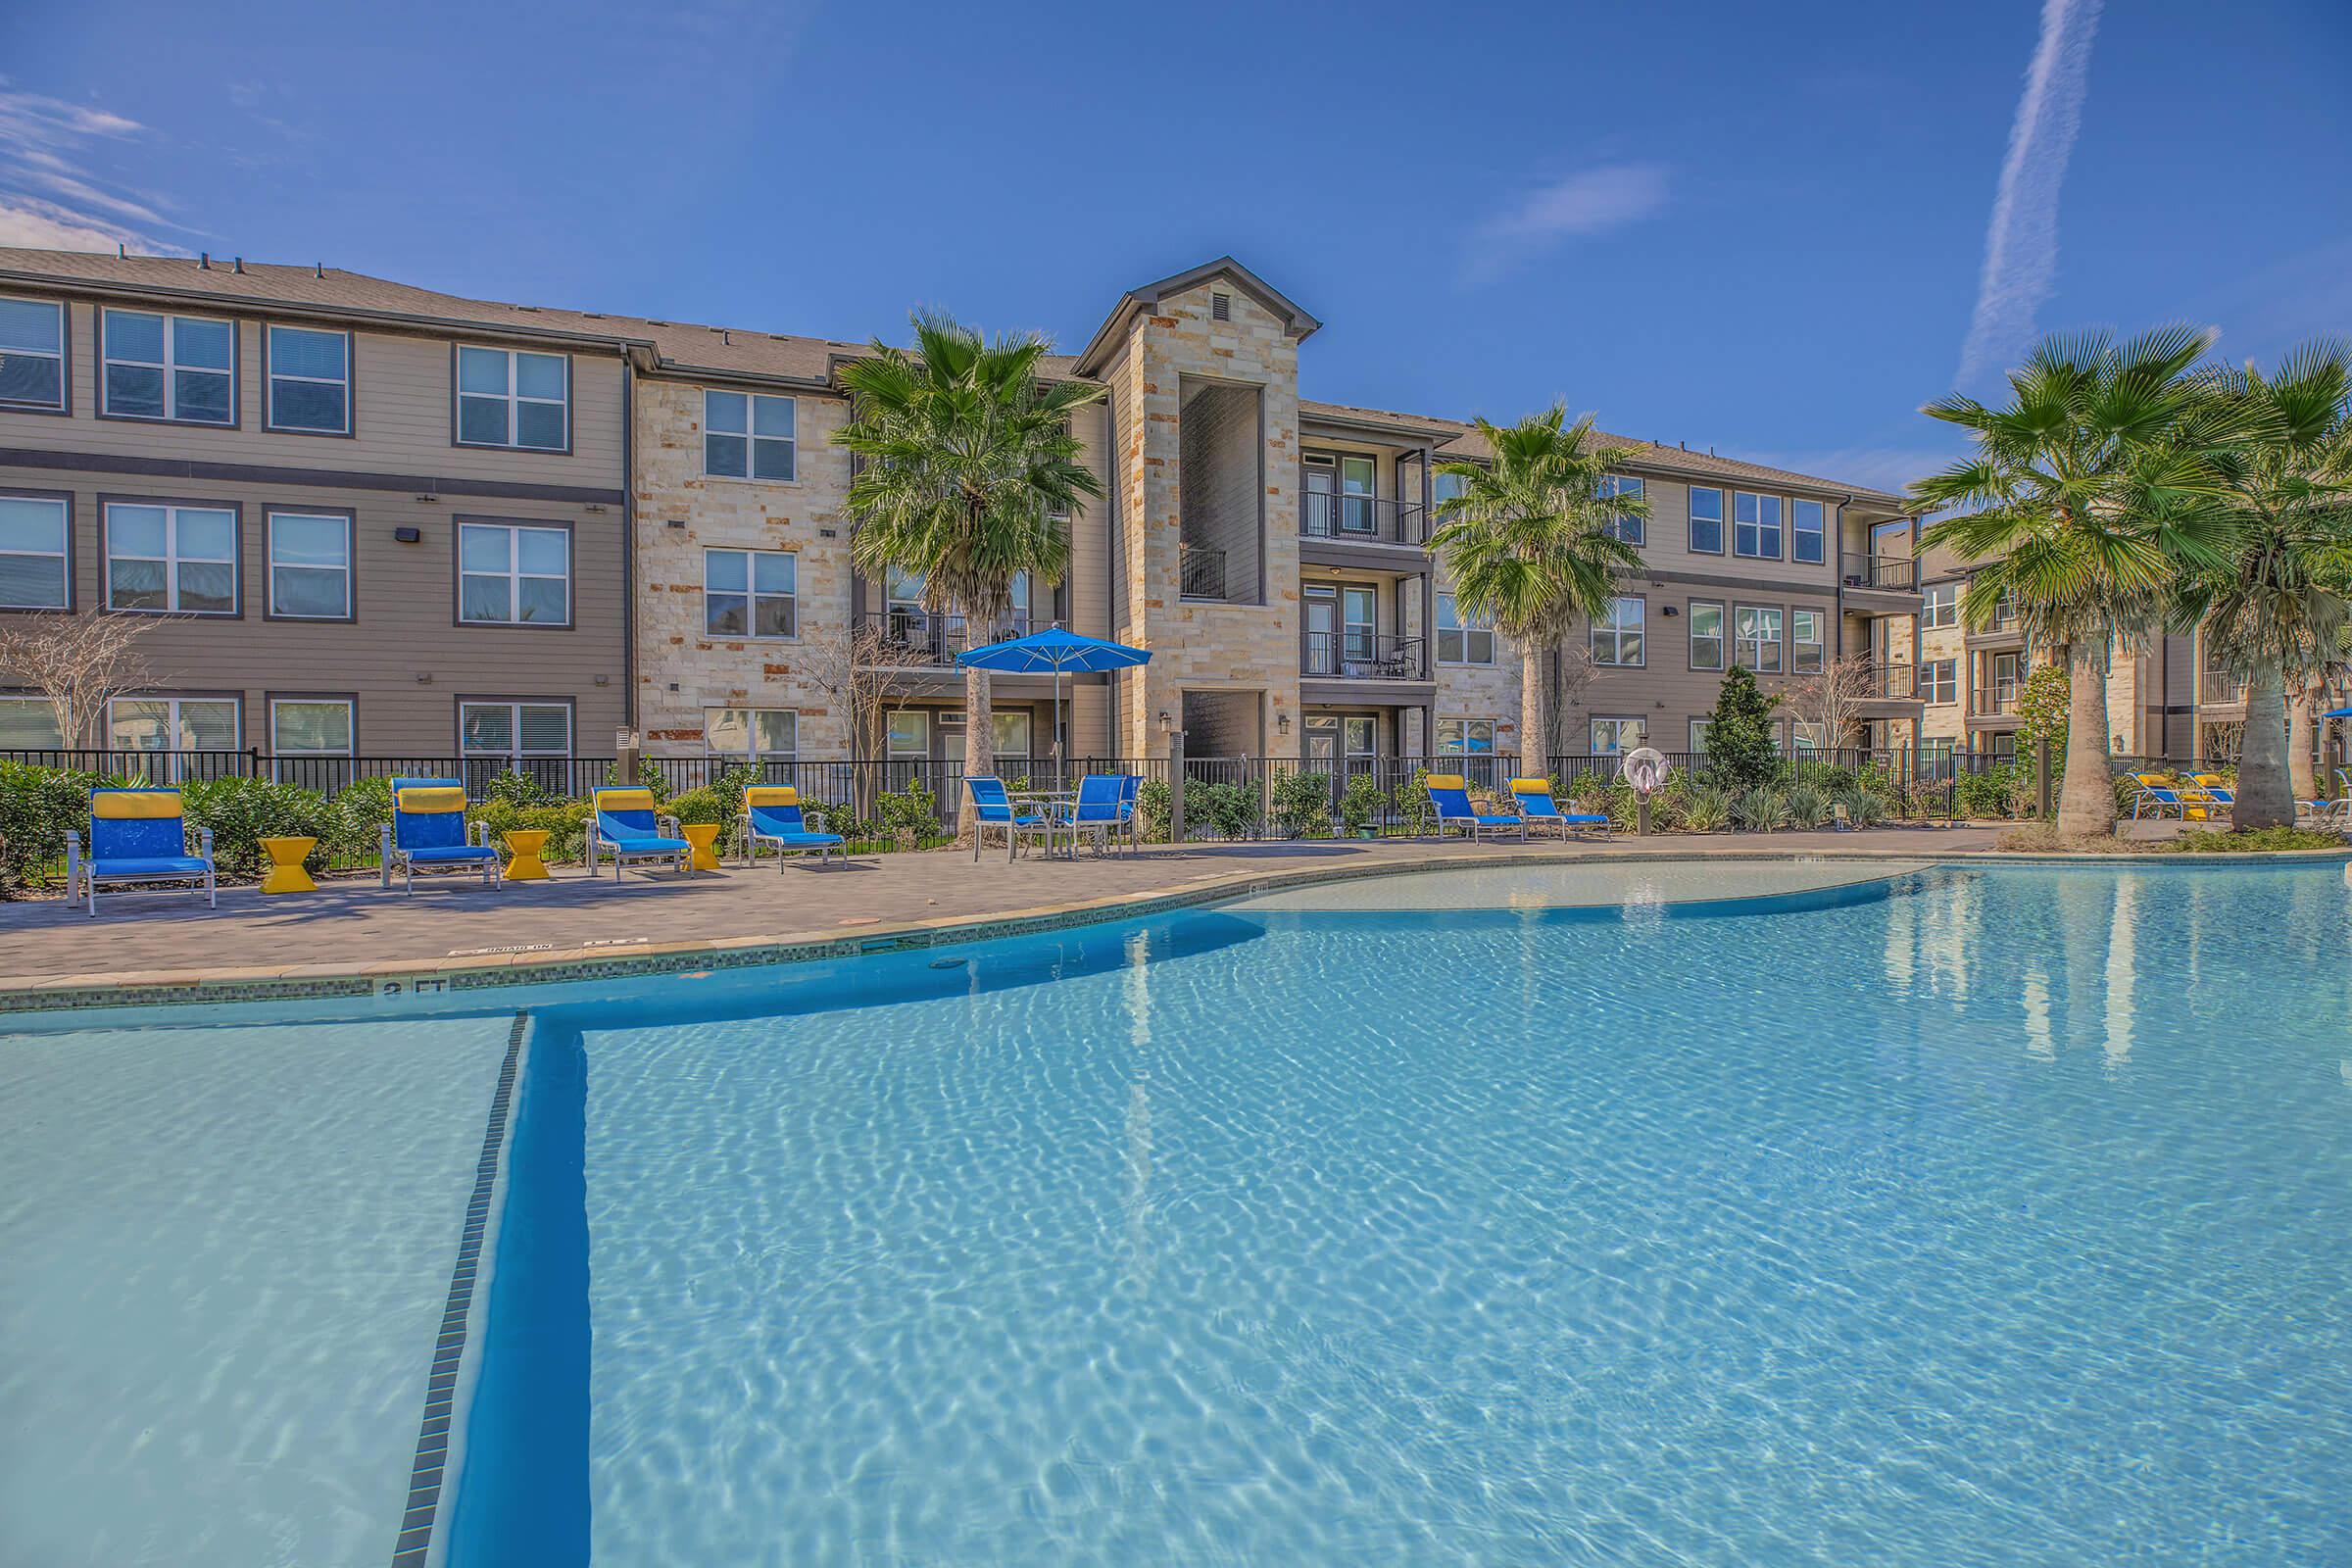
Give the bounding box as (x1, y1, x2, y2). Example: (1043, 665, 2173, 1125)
(1910, 326, 2234, 839)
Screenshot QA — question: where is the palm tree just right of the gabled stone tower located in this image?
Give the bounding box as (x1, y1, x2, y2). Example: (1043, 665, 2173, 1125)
(1430, 405, 1648, 766)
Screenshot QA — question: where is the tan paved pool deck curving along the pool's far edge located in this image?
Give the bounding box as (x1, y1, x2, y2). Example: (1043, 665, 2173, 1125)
(0, 825, 2332, 1013)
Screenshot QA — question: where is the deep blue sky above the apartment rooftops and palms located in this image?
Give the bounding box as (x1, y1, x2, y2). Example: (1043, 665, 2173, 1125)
(0, 0, 2352, 484)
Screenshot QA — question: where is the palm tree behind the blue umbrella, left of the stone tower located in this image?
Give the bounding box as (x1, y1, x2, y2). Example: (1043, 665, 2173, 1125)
(833, 311, 1103, 832)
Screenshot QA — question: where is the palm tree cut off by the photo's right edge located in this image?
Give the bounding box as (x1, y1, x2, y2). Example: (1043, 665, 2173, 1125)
(2178, 343, 2352, 827)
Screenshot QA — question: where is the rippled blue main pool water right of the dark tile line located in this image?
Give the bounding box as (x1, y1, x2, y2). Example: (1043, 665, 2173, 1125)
(0, 867, 2352, 1568)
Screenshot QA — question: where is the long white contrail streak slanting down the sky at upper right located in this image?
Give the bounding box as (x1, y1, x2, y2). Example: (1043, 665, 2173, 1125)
(1959, 0, 2103, 385)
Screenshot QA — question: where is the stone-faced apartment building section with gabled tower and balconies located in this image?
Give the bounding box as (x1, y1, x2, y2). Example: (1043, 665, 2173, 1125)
(633, 259, 1919, 768)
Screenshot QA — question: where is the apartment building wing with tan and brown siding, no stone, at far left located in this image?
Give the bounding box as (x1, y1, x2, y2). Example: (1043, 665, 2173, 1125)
(0, 249, 645, 766)
